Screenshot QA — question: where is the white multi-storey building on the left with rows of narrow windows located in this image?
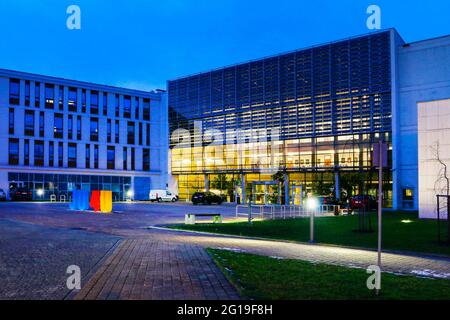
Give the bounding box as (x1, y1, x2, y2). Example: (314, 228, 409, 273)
(0, 70, 168, 201)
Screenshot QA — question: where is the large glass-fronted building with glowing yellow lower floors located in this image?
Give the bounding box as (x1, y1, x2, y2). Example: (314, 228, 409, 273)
(168, 30, 402, 206)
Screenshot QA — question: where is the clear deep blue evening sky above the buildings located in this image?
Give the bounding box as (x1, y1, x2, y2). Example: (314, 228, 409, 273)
(0, 0, 450, 90)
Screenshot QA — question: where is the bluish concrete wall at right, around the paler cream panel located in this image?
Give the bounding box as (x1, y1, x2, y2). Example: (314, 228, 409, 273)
(393, 36, 450, 210)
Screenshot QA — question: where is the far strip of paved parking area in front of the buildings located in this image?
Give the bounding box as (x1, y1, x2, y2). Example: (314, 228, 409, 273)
(0, 202, 239, 237)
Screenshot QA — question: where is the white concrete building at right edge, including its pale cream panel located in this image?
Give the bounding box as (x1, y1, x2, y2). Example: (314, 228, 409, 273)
(394, 36, 450, 218)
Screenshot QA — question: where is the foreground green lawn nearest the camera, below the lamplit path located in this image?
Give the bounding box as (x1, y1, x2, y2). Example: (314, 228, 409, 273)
(208, 249, 450, 300)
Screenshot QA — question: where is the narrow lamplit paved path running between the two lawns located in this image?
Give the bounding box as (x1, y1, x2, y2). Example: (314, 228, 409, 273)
(150, 230, 450, 279)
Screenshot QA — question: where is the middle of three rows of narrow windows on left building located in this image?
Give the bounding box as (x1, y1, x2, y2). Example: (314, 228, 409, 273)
(9, 108, 150, 146)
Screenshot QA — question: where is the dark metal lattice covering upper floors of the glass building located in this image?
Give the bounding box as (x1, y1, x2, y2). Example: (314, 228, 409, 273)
(168, 31, 391, 144)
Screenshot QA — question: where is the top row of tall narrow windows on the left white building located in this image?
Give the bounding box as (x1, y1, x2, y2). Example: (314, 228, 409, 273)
(9, 79, 150, 121)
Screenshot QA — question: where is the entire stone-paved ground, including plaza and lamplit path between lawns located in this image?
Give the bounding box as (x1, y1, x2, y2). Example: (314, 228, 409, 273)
(0, 203, 450, 300)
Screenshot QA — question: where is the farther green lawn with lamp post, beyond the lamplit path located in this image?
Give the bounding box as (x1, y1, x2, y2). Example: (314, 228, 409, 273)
(172, 212, 450, 256)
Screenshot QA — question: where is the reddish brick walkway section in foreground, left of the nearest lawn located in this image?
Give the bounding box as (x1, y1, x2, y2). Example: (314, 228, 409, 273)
(75, 239, 239, 300)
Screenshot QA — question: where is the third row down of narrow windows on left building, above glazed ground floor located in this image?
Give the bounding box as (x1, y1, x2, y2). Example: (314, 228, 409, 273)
(8, 138, 150, 171)
